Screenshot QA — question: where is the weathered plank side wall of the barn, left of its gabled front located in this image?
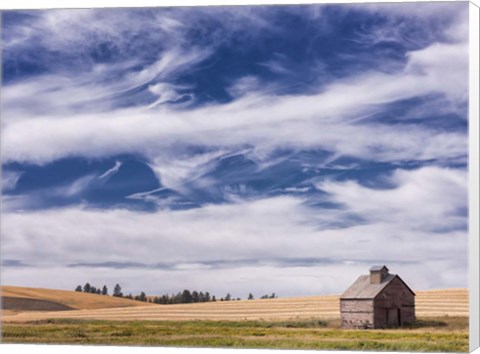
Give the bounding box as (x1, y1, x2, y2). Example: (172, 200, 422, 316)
(340, 300, 374, 328)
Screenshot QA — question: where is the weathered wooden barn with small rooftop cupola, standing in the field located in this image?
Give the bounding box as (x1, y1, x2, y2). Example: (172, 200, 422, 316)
(340, 266, 415, 328)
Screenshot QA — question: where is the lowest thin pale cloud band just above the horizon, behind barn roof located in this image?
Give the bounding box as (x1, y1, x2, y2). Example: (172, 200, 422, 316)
(2, 260, 467, 299)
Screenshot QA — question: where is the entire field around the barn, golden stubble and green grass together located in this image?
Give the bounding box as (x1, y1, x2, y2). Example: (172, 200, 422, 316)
(2, 289, 468, 352)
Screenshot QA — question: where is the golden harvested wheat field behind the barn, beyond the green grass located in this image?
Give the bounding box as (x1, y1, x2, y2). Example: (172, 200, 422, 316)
(2, 287, 468, 322)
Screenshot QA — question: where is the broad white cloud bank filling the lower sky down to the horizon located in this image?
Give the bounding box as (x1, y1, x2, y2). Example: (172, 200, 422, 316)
(2, 168, 468, 295)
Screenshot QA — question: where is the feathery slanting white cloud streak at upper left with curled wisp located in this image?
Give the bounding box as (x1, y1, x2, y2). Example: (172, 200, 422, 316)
(2, 47, 210, 121)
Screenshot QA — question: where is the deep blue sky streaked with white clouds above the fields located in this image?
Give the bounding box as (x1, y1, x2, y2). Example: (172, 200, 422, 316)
(1, 2, 468, 298)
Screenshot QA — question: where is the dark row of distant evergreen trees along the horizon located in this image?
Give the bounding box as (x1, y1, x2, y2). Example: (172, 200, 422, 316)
(75, 283, 277, 305)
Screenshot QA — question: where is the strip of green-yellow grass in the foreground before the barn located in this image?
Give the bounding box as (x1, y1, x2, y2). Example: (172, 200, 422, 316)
(2, 317, 468, 352)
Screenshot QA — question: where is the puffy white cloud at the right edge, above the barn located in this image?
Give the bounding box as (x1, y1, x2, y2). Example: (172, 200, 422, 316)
(317, 167, 467, 231)
